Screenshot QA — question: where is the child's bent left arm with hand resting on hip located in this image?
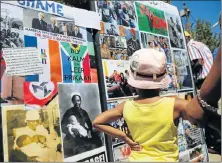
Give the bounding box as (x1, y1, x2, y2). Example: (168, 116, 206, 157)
(93, 102, 141, 151)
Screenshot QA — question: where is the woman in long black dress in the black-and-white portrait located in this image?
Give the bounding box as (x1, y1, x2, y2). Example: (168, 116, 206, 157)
(61, 92, 102, 158)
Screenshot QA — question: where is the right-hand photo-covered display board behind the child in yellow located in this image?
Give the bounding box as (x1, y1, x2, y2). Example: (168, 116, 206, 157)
(95, 1, 208, 161)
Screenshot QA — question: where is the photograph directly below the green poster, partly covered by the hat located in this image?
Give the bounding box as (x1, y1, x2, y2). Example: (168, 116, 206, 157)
(140, 32, 172, 63)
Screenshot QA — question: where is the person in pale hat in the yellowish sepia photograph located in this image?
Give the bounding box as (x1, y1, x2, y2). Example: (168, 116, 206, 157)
(9, 110, 61, 162)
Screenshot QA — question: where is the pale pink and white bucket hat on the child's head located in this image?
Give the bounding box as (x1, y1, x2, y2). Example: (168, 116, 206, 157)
(128, 48, 171, 89)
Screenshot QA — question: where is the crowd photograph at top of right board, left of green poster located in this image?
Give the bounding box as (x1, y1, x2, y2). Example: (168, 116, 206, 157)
(96, 1, 137, 28)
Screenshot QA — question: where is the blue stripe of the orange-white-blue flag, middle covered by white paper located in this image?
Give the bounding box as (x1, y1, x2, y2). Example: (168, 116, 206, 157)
(24, 36, 39, 82)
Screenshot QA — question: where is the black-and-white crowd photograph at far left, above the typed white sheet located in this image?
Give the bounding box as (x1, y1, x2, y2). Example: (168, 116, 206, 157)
(0, 3, 24, 48)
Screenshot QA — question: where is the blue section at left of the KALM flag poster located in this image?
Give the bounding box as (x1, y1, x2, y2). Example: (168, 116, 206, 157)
(60, 48, 73, 83)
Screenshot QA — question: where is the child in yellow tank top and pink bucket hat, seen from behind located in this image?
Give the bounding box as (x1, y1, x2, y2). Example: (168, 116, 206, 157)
(93, 49, 204, 162)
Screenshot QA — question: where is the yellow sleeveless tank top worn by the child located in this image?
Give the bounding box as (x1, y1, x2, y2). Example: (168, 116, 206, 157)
(123, 97, 179, 162)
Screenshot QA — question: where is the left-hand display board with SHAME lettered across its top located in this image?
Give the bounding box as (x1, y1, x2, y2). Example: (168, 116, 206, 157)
(1, 1, 108, 162)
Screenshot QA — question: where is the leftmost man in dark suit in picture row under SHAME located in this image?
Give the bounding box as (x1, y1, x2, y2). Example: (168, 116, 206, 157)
(32, 12, 47, 31)
